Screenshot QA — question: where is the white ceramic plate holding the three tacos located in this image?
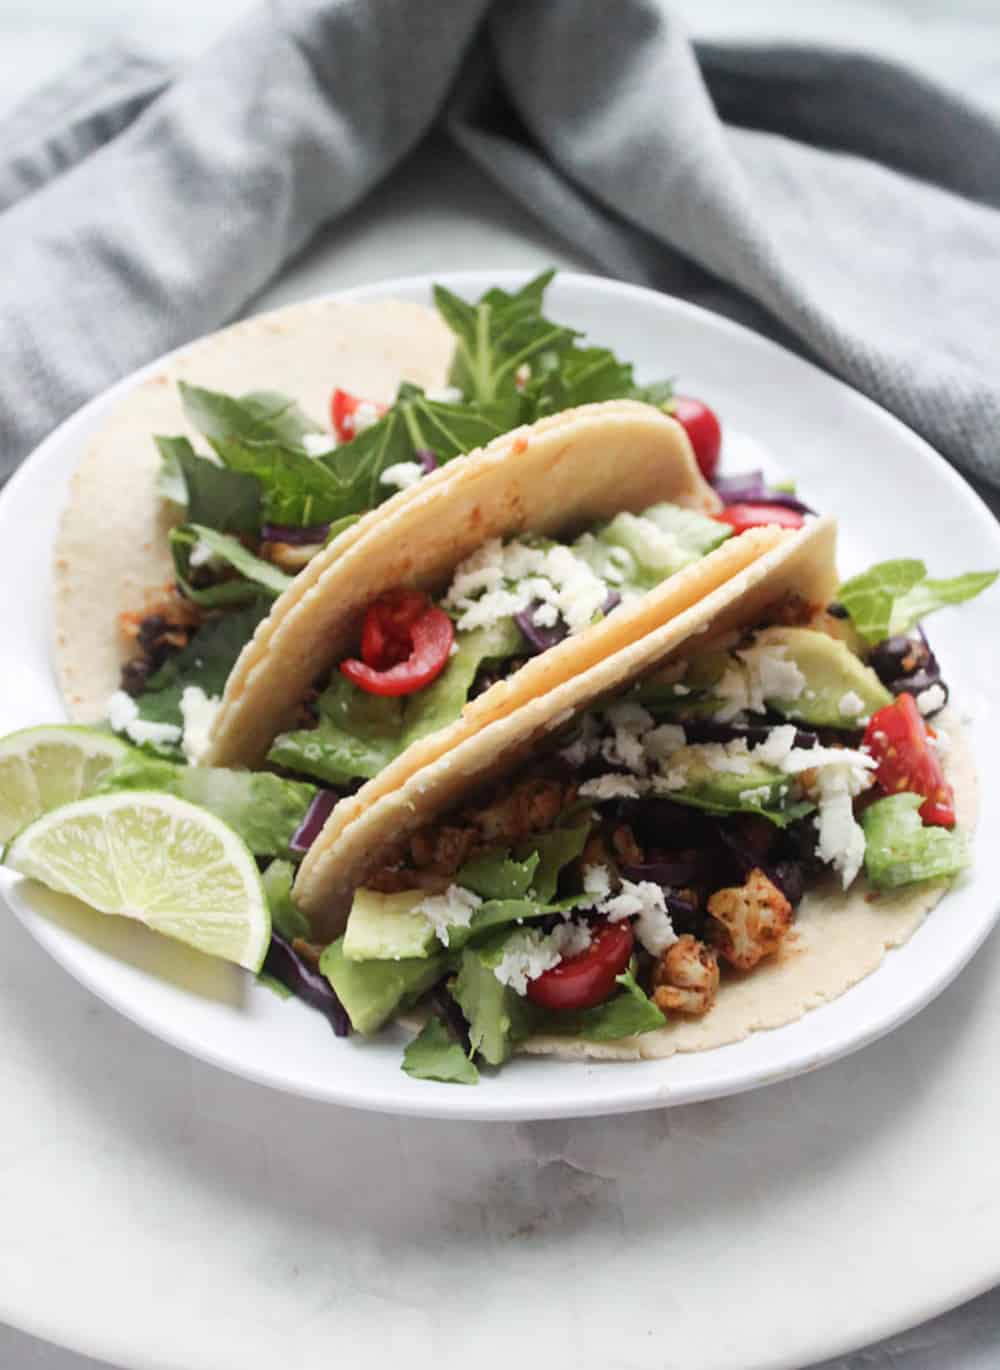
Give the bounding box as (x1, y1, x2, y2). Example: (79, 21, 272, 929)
(0, 273, 1000, 1119)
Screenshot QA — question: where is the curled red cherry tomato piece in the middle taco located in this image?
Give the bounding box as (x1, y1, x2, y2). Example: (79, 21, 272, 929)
(340, 590, 455, 696)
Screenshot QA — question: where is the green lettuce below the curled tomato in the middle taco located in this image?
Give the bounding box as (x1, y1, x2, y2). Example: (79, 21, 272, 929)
(267, 619, 523, 785)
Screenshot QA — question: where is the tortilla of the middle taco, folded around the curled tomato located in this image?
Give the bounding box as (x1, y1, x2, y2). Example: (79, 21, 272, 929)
(204, 400, 723, 780)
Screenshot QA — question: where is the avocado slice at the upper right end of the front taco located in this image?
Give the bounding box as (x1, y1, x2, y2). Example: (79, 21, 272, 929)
(753, 627, 893, 727)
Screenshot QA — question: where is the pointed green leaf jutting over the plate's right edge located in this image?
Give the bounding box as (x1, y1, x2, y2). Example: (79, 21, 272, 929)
(837, 558, 1000, 643)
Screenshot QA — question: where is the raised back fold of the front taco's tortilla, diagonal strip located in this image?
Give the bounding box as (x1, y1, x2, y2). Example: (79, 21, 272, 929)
(295, 519, 837, 937)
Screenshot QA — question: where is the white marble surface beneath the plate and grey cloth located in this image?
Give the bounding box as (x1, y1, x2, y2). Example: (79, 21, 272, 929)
(0, 0, 1000, 1370)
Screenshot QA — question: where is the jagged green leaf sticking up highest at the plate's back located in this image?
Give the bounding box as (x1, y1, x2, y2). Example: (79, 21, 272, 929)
(434, 271, 578, 429)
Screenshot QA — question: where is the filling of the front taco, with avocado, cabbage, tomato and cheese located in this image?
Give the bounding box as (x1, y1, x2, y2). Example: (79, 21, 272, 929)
(312, 585, 967, 1078)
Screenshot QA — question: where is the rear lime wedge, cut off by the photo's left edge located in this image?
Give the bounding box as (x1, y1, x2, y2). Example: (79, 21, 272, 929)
(0, 725, 132, 845)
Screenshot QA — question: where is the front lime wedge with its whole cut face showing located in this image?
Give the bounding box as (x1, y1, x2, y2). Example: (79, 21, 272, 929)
(4, 790, 271, 970)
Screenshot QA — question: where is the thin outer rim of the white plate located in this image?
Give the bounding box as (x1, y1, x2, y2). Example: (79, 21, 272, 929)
(0, 269, 1000, 1121)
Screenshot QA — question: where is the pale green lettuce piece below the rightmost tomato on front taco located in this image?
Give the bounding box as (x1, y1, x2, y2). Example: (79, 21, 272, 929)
(862, 793, 968, 889)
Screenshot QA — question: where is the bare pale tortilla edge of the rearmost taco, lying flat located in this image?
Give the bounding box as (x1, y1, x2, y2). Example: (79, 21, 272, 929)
(53, 300, 453, 722)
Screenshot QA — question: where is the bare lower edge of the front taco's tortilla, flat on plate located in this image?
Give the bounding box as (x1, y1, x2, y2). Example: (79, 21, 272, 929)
(518, 715, 977, 1060)
